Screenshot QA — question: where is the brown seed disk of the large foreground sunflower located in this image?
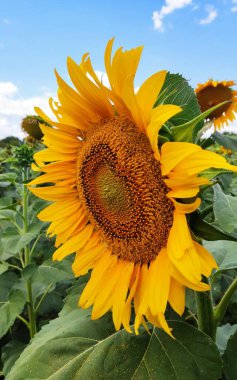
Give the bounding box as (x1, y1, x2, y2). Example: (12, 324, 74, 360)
(77, 117, 174, 263)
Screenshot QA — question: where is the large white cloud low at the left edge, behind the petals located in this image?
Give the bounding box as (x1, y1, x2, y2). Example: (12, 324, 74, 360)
(0, 82, 52, 139)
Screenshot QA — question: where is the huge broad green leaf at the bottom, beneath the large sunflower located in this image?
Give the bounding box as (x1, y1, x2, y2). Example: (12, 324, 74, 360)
(6, 309, 222, 380)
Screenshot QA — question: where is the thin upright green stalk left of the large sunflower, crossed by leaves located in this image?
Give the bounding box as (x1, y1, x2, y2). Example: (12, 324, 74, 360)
(22, 168, 37, 338)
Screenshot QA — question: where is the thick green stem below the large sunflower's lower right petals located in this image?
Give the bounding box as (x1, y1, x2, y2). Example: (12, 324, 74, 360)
(195, 278, 217, 342)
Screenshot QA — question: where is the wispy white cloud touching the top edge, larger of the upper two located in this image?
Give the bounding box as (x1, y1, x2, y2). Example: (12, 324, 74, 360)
(152, 0, 192, 32)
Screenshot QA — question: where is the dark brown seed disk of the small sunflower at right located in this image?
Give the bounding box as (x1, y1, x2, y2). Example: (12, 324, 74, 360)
(197, 84, 232, 119)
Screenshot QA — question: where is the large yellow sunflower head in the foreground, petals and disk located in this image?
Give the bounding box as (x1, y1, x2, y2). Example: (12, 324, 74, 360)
(30, 40, 237, 334)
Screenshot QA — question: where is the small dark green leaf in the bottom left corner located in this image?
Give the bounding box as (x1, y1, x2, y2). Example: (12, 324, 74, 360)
(2, 340, 26, 376)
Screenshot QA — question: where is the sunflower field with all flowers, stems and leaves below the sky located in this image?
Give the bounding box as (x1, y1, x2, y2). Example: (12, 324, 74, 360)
(0, 40, 237, 380)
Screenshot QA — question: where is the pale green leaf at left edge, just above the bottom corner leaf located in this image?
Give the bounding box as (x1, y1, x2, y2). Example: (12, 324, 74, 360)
(0, 290, 26, 338)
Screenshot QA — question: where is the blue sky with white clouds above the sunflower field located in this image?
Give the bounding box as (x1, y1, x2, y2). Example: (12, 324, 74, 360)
(0, 0, 237, 138)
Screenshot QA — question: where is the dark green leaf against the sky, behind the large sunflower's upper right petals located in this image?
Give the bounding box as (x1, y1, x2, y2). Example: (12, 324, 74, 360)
(154, 73, 201, 125)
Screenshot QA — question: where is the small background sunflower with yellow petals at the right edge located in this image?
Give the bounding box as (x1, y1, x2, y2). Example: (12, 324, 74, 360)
(195, 79, 237, 129)
